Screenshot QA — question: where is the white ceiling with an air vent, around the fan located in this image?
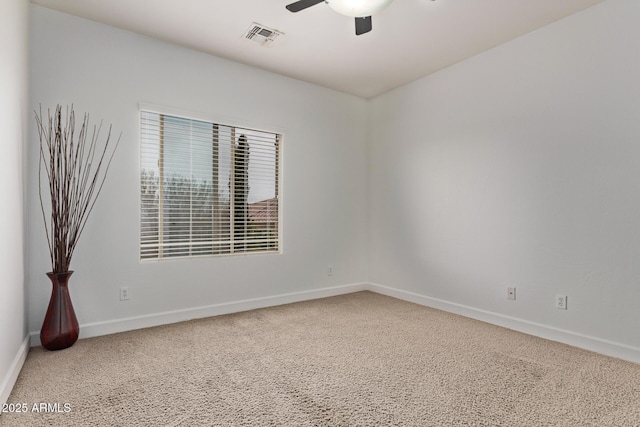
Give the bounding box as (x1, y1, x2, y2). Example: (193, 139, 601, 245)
(31, 0, 603, 98)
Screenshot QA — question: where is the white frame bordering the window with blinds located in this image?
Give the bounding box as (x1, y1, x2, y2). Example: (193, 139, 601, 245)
(137, 103, 285, 263)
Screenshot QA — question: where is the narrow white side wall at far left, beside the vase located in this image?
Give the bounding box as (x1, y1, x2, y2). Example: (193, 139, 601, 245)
(0, 0, 29, 404)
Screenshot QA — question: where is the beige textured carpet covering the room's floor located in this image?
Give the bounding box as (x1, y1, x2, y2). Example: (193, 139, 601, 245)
(0, 292, 640, 427)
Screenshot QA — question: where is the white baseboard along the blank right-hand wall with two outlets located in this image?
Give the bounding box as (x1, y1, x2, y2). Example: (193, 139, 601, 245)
(368, 283, 640, 363)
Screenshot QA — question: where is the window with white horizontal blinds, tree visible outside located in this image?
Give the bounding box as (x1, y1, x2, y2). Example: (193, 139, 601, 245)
(140, 111, 281, 260)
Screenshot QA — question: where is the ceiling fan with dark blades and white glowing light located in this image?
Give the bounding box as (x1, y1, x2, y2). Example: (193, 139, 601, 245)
(287, 0, 393, 36)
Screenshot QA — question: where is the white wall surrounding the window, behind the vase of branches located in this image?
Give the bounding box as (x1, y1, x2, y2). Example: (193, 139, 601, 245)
(27, 6, 366, 338)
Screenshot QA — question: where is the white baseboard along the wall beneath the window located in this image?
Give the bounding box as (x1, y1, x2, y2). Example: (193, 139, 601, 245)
(30, 283, 368, 347)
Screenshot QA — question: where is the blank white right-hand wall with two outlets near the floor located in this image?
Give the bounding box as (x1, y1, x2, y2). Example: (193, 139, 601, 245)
(368, 0, 640, 357)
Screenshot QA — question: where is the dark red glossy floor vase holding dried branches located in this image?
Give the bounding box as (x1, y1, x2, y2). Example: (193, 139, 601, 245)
(40, 271, 80, 350)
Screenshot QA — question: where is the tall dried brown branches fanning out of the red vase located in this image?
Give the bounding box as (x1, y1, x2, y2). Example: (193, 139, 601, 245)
(35, 105, 122, 273)
